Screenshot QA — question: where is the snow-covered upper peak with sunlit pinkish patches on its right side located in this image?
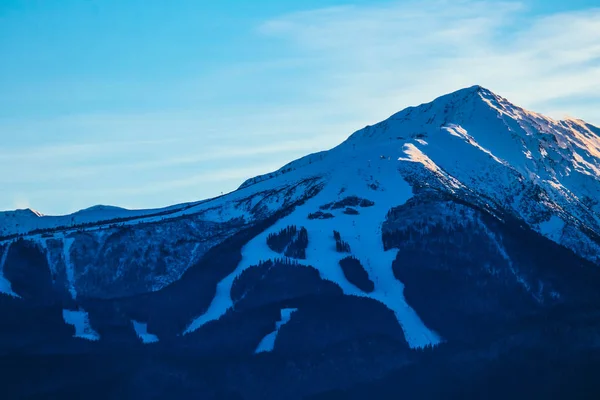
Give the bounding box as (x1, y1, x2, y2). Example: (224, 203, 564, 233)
(242, 86, 600, 261)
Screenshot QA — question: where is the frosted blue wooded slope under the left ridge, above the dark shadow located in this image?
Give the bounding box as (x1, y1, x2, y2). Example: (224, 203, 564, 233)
(0, 178, 320, 299)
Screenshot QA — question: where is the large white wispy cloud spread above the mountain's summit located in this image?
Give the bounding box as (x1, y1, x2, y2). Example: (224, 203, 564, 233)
(259, 0, 600, 123)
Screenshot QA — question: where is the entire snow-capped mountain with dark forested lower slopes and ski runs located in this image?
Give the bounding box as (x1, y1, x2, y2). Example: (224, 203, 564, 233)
(0, 86, 600, 399)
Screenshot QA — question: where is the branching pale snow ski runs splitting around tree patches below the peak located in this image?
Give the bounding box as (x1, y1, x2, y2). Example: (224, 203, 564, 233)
(186, 142, 440, 347)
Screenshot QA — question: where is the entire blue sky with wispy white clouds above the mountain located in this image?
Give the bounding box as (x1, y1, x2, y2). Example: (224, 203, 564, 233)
(0, 0, 600, 214)
